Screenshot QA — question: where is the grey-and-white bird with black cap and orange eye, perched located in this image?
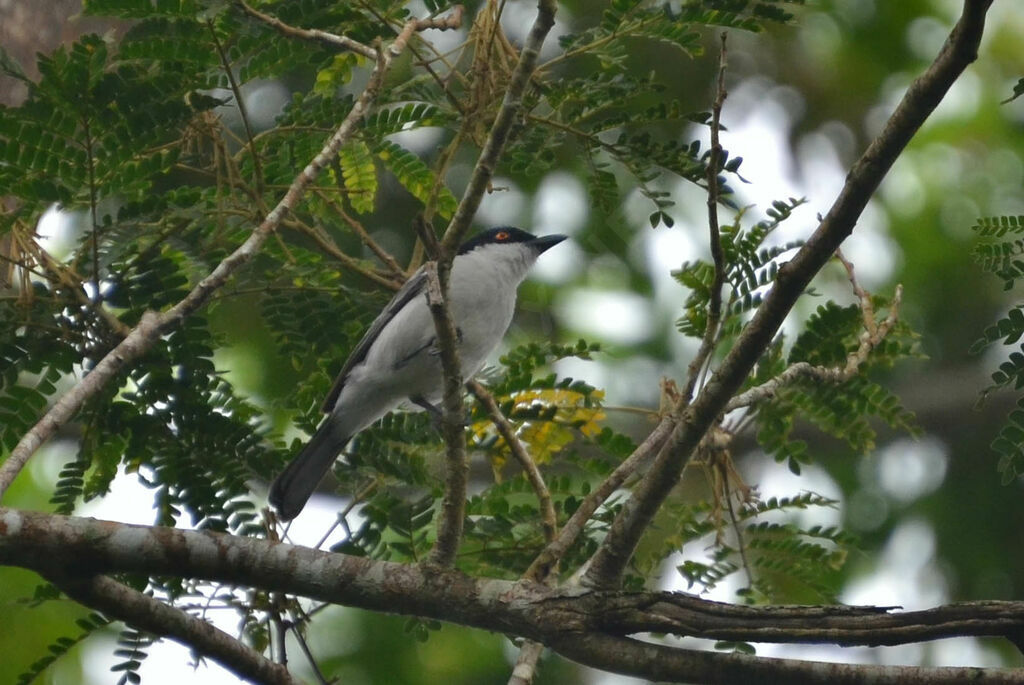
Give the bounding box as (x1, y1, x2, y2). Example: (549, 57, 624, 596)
(268, 226, 566, 521)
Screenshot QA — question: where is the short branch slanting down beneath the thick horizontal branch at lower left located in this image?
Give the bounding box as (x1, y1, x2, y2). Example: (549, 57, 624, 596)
(48, 575, 295, 685)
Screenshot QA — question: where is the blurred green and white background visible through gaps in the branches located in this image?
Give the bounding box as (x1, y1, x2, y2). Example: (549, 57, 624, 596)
(0, 0, 1024, 685)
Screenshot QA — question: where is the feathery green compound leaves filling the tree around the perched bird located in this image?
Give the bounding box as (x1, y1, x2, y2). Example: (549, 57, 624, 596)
(0, 0, 929, 671)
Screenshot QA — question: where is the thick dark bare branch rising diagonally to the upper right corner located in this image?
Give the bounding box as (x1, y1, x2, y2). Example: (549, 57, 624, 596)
(585, 0, 991, 586)
